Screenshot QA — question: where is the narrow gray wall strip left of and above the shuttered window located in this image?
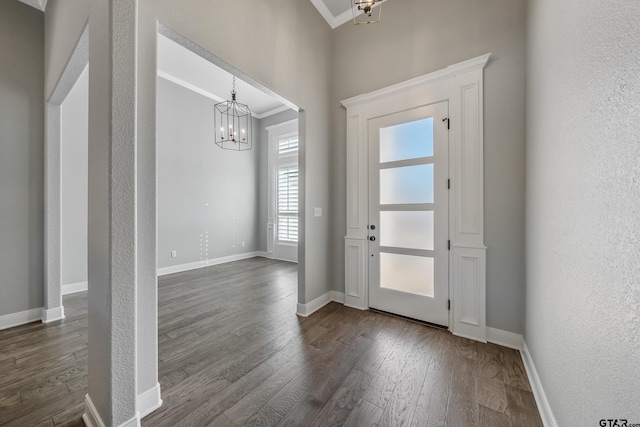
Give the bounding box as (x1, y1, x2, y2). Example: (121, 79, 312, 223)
(257, 110, 298, 252)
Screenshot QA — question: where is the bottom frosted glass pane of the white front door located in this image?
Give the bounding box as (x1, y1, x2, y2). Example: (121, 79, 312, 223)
(380, 252, 434, 297)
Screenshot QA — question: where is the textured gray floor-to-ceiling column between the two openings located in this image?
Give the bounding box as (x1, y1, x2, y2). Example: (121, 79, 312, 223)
(83, 0, 140, 426)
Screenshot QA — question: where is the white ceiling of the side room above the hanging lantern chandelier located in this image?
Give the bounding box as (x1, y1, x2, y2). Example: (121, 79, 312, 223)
(158, 34, 289, 119)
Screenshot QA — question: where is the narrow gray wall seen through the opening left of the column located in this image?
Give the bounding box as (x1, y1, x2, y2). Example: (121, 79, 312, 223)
(60, 68, 89, 285)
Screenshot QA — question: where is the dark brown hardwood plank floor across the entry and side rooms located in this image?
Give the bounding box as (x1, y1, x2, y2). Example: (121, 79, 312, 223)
(0, 258, 542, 427)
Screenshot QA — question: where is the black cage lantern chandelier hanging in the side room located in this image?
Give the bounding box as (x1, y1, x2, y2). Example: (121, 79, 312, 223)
(218, 76, 252, 151)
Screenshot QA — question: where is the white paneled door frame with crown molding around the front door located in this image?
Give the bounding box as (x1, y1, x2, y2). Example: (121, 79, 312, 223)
(342, 54, 491, 342)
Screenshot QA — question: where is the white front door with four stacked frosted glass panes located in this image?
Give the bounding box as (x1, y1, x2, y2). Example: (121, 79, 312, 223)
(368, 102, 449, 326)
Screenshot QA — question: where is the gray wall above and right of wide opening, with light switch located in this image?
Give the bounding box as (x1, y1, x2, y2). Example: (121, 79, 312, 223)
(139, 0, 331, 302)
